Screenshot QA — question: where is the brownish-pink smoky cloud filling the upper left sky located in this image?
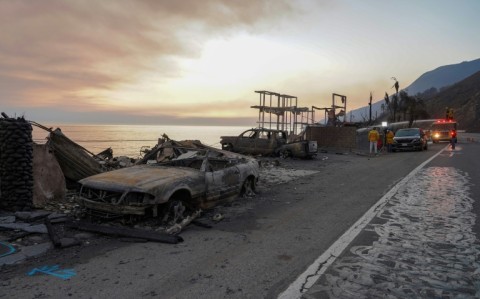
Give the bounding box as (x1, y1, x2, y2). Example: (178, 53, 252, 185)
(0, 0, 294, 111)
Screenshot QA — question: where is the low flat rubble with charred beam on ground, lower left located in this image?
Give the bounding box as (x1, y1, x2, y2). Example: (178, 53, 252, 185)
(0, 206, 183, 267)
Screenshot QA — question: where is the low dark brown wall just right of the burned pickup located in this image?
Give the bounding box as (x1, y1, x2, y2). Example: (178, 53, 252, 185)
(305, 127, 357, 149)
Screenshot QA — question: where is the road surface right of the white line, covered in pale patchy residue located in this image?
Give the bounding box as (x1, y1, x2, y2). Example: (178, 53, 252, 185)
(302, 134, 480, 298)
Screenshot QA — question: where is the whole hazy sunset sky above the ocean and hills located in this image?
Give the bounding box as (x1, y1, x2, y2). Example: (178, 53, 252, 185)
(0, 0, 480, 127)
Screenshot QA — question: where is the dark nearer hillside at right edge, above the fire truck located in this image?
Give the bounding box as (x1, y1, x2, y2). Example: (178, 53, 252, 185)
(425, 72, 480, 133)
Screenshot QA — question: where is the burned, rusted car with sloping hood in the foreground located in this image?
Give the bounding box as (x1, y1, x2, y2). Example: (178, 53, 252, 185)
(79, 145, 259, 218)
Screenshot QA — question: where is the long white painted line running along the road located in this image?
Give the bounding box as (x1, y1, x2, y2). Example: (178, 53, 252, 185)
(278, 147, 448, 299)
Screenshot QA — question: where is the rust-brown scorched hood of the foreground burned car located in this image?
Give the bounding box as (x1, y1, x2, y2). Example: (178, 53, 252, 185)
(79, 165, 202, 192)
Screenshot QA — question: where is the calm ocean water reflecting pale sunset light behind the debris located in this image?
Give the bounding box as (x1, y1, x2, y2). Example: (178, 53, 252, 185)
(32, 124, 250, 158)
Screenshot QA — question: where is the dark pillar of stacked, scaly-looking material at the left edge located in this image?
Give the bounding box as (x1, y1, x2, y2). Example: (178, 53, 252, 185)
(0, 112, 33, 211)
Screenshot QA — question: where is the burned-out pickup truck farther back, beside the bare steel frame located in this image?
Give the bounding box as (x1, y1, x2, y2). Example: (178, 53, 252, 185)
(220, 128, 317, 158)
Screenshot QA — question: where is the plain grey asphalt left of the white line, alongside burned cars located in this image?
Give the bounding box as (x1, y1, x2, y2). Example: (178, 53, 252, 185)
(0, 134, 480, 298)
